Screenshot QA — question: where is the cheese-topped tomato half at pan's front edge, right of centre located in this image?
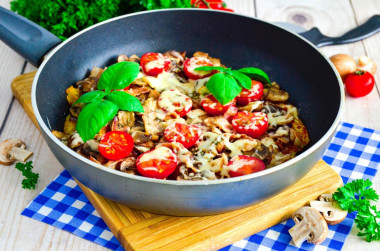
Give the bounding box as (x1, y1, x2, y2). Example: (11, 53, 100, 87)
(228, 155, 265, 177)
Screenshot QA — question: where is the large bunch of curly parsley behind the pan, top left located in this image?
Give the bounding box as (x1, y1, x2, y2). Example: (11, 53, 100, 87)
(11, 0, 191, 40)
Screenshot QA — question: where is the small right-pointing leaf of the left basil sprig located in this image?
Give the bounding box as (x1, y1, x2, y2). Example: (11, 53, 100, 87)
(106, 91, 144, 112)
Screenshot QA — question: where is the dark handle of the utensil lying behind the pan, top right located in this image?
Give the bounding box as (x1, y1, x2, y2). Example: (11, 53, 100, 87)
(305, 15, 380, 47)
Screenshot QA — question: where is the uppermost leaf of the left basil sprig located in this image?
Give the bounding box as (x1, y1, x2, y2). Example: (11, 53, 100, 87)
(98, 61, 140, 90)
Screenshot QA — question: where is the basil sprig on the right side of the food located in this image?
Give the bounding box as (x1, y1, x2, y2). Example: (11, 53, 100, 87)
(195, 66, 270, 105)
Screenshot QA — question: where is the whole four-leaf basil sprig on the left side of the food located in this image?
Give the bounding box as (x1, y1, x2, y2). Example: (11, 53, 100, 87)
(74, 62, 144, 142)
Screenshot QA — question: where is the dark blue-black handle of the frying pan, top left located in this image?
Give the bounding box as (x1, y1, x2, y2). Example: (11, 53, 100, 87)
(0, 7, 61, 66)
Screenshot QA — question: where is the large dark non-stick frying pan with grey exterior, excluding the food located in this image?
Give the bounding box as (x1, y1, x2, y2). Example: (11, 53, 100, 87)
(0, 9, 344, 216)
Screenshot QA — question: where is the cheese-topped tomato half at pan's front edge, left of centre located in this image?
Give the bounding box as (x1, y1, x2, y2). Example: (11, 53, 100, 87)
(136, 146, 177, 179)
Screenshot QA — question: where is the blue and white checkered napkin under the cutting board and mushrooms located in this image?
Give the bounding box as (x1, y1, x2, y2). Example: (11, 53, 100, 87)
(21, 123, 380, 251)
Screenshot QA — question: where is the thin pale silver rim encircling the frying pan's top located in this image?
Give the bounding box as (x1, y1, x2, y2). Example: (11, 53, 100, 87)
(32, 8, 345, 186)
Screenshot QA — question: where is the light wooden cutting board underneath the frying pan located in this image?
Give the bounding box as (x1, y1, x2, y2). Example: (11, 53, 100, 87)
(11, 72, 343, 250)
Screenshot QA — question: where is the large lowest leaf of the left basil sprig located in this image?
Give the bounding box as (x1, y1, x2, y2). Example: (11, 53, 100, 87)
(76, 100, 119, 142)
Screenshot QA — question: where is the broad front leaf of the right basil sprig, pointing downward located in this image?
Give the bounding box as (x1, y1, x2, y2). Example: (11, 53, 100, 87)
(206, 73, 241, 105)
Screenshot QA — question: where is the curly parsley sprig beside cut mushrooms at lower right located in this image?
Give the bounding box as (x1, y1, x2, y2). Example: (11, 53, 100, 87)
(333, 179, 380, 242)
